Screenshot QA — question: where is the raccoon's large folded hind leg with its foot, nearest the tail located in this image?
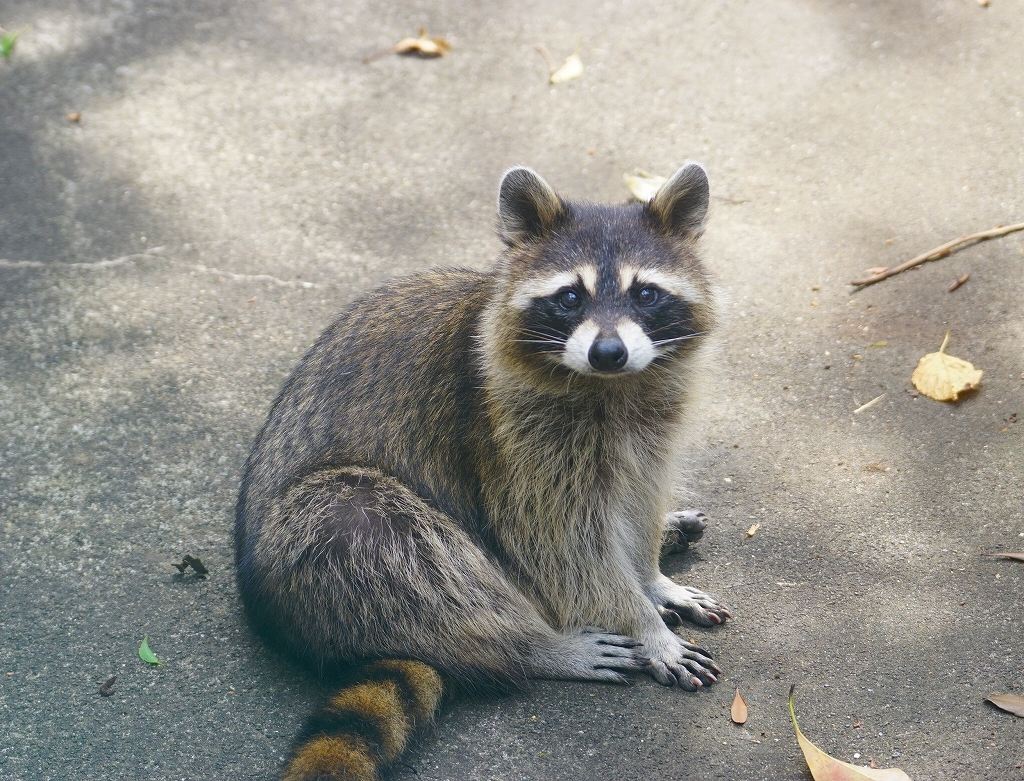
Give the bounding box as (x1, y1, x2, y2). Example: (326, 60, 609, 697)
(240, 468, 646, 686)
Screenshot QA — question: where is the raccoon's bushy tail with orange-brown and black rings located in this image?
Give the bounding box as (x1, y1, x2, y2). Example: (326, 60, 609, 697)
(282, 659, 443, 781)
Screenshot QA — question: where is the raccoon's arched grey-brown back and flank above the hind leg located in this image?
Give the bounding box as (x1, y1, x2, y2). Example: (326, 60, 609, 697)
(236, 269, 493, 559)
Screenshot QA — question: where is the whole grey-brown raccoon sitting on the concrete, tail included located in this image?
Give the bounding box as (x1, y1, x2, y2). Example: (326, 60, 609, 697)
(236, 163, 730, 781)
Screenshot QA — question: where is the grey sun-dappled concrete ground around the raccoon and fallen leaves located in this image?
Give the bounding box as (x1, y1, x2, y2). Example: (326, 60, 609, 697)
(0, 0, 1024, 781)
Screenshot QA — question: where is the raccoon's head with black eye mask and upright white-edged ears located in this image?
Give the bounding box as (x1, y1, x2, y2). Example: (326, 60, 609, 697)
(488, 163, 714, 388)
